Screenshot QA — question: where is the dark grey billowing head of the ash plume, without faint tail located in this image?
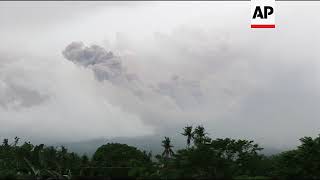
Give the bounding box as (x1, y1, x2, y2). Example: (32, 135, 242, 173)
(62, 42, 147, 96)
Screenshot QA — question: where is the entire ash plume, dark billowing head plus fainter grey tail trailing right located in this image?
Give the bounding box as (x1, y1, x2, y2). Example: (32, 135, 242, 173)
(62, 42, 203, 109)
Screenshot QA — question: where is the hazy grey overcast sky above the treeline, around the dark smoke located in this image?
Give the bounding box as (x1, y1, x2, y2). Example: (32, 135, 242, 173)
(0, 2, 320, 147)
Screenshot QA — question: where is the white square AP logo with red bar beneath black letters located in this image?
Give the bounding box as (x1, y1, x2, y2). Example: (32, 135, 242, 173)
(251, 0, 276, 28)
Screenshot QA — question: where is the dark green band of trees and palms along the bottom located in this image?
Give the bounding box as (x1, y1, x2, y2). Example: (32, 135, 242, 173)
(0, 126, 320, 179)
